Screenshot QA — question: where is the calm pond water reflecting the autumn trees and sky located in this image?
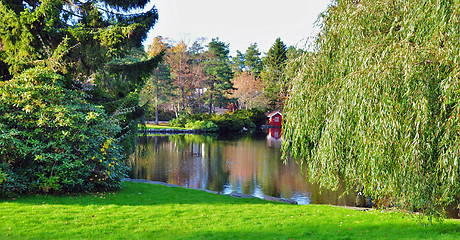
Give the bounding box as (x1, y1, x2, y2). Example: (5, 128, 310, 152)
(130, 129, 356, 206)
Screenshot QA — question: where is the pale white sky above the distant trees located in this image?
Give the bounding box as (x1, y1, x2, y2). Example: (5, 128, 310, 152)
(144, 0, 331, 56)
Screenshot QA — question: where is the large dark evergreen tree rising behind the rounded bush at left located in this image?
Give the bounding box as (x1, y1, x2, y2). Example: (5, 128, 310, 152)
(0, 0, 161, 146)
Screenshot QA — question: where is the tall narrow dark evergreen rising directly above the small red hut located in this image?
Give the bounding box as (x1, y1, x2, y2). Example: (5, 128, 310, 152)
(261, 38, 288, 110)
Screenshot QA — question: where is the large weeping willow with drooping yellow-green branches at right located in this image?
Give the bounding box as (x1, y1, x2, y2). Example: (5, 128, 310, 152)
(283, 0, 460, 216)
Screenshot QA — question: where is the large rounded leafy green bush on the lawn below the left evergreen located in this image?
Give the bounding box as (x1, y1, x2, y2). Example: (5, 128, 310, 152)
(0, 68, 127, 195)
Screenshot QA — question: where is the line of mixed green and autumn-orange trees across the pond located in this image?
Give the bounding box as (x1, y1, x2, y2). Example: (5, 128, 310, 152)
(141, 36, 303, 123)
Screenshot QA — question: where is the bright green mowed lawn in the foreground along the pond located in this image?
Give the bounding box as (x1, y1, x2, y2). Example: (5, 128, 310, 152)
(0, 182, 460, 239)
